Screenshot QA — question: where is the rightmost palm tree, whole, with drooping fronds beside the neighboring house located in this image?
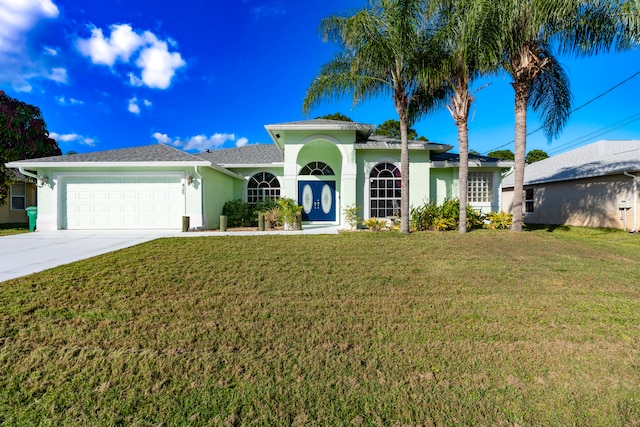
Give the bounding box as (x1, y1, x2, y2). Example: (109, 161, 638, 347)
(494, 0, 638, 232)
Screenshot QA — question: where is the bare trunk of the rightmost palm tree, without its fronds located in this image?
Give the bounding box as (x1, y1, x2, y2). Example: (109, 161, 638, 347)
(511, 81, 529, 233)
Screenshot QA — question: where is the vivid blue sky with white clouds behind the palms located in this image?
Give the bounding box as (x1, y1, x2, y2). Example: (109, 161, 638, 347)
(0, 0, 640, 158)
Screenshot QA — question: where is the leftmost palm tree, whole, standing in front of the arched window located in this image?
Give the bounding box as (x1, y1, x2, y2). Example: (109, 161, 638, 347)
(303, 0, 444, 233)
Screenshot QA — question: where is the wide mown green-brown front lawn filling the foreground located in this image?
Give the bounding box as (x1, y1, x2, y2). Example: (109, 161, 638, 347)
(0, 229, 640, 426)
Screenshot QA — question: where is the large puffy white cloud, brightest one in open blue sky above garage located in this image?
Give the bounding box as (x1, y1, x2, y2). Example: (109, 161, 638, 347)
(76, 24, 186, 89)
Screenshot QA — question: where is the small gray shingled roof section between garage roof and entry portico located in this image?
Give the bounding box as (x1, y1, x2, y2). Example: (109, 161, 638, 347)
(196, 144, 284, 167)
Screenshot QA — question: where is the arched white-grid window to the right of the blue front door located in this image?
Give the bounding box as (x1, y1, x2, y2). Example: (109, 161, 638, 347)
(369, 163, 401, 218)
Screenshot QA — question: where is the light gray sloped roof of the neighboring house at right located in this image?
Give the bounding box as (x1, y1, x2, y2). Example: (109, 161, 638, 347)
(503, 140, 640, 187)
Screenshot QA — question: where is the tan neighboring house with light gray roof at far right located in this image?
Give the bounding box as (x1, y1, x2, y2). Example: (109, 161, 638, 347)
(502, 141, 640, 231)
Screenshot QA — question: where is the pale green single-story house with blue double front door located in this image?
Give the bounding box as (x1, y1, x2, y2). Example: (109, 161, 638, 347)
(7, 119, 513, 230)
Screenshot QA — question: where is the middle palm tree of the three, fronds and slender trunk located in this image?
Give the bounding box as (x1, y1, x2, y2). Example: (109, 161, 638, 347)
(430, 0, 500, 233)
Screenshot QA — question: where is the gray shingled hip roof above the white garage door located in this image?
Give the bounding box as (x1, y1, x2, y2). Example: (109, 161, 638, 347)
(7, 144, 211, 168)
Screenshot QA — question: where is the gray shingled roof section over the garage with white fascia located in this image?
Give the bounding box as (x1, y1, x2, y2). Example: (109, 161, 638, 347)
(5, 144, 208, 167)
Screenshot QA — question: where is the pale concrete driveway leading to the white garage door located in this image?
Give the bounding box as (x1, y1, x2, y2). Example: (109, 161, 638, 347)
(0, 230, 180, 282)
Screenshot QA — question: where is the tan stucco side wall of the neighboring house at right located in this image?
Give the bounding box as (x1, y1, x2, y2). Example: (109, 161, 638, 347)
(502, 175, 640, 230)
